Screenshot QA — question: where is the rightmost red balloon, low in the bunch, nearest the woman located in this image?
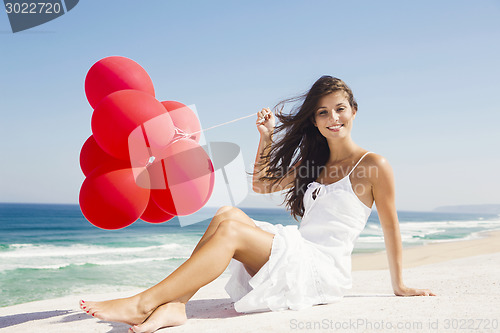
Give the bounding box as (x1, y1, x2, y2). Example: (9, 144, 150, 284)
(148, 139, 215, 216)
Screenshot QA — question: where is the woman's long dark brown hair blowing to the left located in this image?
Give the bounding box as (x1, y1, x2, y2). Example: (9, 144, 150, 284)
(259, 75, 358, 221)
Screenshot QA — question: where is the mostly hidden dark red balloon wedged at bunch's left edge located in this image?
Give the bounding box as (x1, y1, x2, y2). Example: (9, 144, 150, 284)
(80, 135, 130, 176)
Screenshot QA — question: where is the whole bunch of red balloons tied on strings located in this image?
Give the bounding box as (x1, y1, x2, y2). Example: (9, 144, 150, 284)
(79, 57, 214, 229)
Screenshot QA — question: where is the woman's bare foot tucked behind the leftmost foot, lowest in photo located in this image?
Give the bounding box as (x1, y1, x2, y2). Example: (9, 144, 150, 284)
(129, 302, 187, 333)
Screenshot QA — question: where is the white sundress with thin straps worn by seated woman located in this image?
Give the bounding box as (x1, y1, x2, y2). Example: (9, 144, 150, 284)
(225, 152, 371, 313)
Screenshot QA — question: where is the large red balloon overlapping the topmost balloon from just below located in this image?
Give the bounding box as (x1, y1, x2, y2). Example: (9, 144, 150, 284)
(91, 90, 175, 160)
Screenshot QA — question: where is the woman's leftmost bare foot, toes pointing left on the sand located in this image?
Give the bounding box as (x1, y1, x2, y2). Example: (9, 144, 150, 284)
(80, 295, 152, 325)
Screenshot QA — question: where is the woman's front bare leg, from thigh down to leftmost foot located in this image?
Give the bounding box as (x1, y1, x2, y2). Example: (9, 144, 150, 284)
(80, 205, 274, 324)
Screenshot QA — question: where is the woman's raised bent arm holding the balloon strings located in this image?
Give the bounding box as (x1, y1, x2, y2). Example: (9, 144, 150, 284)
(252, 108, 295, 193)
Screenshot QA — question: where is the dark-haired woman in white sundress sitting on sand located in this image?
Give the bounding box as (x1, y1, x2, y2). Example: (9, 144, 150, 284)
(80, 76, 434, 332)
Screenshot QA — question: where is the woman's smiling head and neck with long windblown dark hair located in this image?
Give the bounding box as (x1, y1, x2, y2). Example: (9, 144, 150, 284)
(254, 75, 365, 219)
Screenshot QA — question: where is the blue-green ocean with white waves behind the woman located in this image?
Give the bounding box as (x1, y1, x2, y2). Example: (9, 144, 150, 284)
(0, 203, 500, 307)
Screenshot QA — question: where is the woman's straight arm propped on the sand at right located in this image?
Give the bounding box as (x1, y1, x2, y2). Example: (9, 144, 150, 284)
(370, 154, 435, 296)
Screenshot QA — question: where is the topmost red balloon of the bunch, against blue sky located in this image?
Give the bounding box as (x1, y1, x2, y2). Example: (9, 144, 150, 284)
(85, 56, 155, 108)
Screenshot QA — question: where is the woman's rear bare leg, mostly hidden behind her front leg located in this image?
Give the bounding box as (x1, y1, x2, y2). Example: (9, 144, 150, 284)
(130, 206, 256, 333)
